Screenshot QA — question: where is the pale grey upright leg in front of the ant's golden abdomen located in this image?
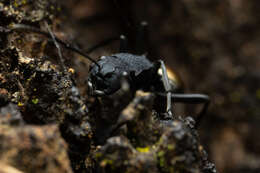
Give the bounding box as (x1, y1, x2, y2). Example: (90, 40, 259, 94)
(159, 60, 173, 117)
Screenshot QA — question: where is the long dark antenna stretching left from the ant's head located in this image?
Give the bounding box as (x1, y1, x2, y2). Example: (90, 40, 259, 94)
(8, 24, 101, 69)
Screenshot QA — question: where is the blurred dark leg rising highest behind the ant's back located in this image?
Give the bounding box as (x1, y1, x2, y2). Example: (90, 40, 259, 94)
(135, 21, 148, 55)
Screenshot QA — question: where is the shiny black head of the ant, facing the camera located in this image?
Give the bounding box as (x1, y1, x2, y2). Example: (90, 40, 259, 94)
(88, 56, 122, 96)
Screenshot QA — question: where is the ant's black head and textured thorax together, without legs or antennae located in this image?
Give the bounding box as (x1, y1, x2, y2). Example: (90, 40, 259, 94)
(88, 53, 160, 95)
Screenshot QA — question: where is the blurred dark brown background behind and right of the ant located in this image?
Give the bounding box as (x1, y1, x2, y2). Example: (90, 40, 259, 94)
(57, 0, 260, 173)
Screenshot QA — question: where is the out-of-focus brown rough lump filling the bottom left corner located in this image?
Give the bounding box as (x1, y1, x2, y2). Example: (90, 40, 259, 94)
(0, 104, 72, 173)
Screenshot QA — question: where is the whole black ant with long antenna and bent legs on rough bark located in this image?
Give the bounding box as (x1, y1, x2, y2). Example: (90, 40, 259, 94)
(7, 22, 210, 127)
